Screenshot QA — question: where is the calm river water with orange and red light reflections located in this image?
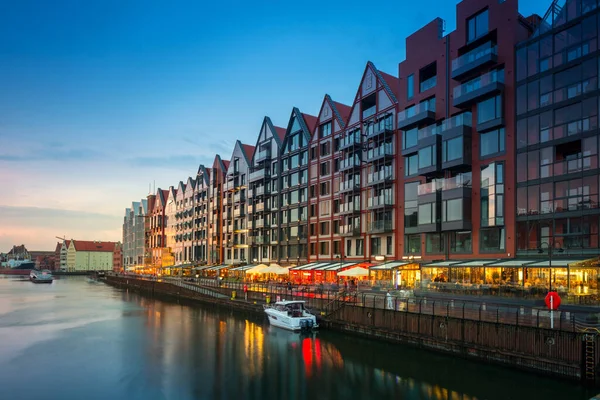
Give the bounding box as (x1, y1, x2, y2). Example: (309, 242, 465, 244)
(0, 276, 596, 400)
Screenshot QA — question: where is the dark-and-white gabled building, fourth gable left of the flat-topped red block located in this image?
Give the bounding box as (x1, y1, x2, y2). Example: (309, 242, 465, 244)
(248, 117, 285, 263)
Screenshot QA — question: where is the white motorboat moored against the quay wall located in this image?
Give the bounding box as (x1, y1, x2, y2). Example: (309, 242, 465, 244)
(264, 300, 319, 331)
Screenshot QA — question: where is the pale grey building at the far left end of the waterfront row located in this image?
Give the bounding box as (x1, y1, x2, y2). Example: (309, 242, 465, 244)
(122, 199, 148, 269)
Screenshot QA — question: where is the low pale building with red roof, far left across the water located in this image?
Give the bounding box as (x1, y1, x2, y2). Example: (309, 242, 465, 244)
(67, 239, 116, 272)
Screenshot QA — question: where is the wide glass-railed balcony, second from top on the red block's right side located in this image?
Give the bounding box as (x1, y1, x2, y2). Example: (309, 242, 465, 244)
(452, 70, 504, 108)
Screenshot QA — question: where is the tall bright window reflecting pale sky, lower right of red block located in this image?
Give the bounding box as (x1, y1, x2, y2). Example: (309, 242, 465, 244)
(481, 163, 504, 227)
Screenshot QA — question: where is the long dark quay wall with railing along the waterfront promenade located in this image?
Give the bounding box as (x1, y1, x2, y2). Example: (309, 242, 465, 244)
(106, 274, 600, 385)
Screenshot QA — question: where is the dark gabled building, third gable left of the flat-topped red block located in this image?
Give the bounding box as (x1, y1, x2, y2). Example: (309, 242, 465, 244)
(280, 107, 317, 265)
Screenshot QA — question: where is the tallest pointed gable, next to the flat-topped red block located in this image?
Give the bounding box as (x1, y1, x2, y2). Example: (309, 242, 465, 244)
(347, 61, 400, 126)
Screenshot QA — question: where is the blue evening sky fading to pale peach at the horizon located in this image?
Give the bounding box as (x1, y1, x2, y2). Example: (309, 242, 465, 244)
(0, 0, 550, 252)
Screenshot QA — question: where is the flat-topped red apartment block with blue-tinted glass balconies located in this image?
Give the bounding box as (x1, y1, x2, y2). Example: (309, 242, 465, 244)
(397, 0, 531, 260)
